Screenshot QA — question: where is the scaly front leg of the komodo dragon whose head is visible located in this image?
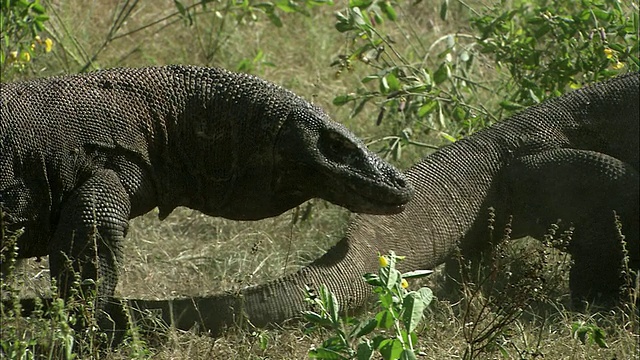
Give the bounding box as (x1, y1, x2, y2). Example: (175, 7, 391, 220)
(49, 169, 131, 320)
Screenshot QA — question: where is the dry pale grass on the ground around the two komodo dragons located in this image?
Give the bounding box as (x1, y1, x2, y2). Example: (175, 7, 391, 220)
(3, 0, 640, 359)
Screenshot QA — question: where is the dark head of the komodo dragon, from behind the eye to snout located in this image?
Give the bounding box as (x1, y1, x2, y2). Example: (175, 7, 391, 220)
(273, 105, 413, 214)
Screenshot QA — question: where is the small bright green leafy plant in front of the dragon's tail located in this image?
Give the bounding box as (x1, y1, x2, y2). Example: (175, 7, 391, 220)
(304, 252, 433, 360)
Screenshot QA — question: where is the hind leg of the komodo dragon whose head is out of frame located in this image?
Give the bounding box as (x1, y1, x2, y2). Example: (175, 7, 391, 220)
(503, 149, 640, 307)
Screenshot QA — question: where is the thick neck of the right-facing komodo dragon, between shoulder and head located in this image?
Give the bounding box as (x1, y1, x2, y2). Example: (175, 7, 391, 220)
(131, 66, 305, 219)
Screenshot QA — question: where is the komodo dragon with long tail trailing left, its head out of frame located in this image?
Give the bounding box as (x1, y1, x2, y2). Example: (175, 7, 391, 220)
(122, 73, 640, 334)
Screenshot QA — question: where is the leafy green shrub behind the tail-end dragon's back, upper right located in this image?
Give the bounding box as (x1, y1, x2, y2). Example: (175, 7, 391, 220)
(332, 0, 640, 158)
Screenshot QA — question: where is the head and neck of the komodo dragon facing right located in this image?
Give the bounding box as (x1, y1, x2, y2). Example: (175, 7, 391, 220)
(159, 67, 413, 220)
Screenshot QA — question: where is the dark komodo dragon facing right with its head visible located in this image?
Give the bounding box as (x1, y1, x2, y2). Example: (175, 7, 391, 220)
(0, 66, 412, 326)
